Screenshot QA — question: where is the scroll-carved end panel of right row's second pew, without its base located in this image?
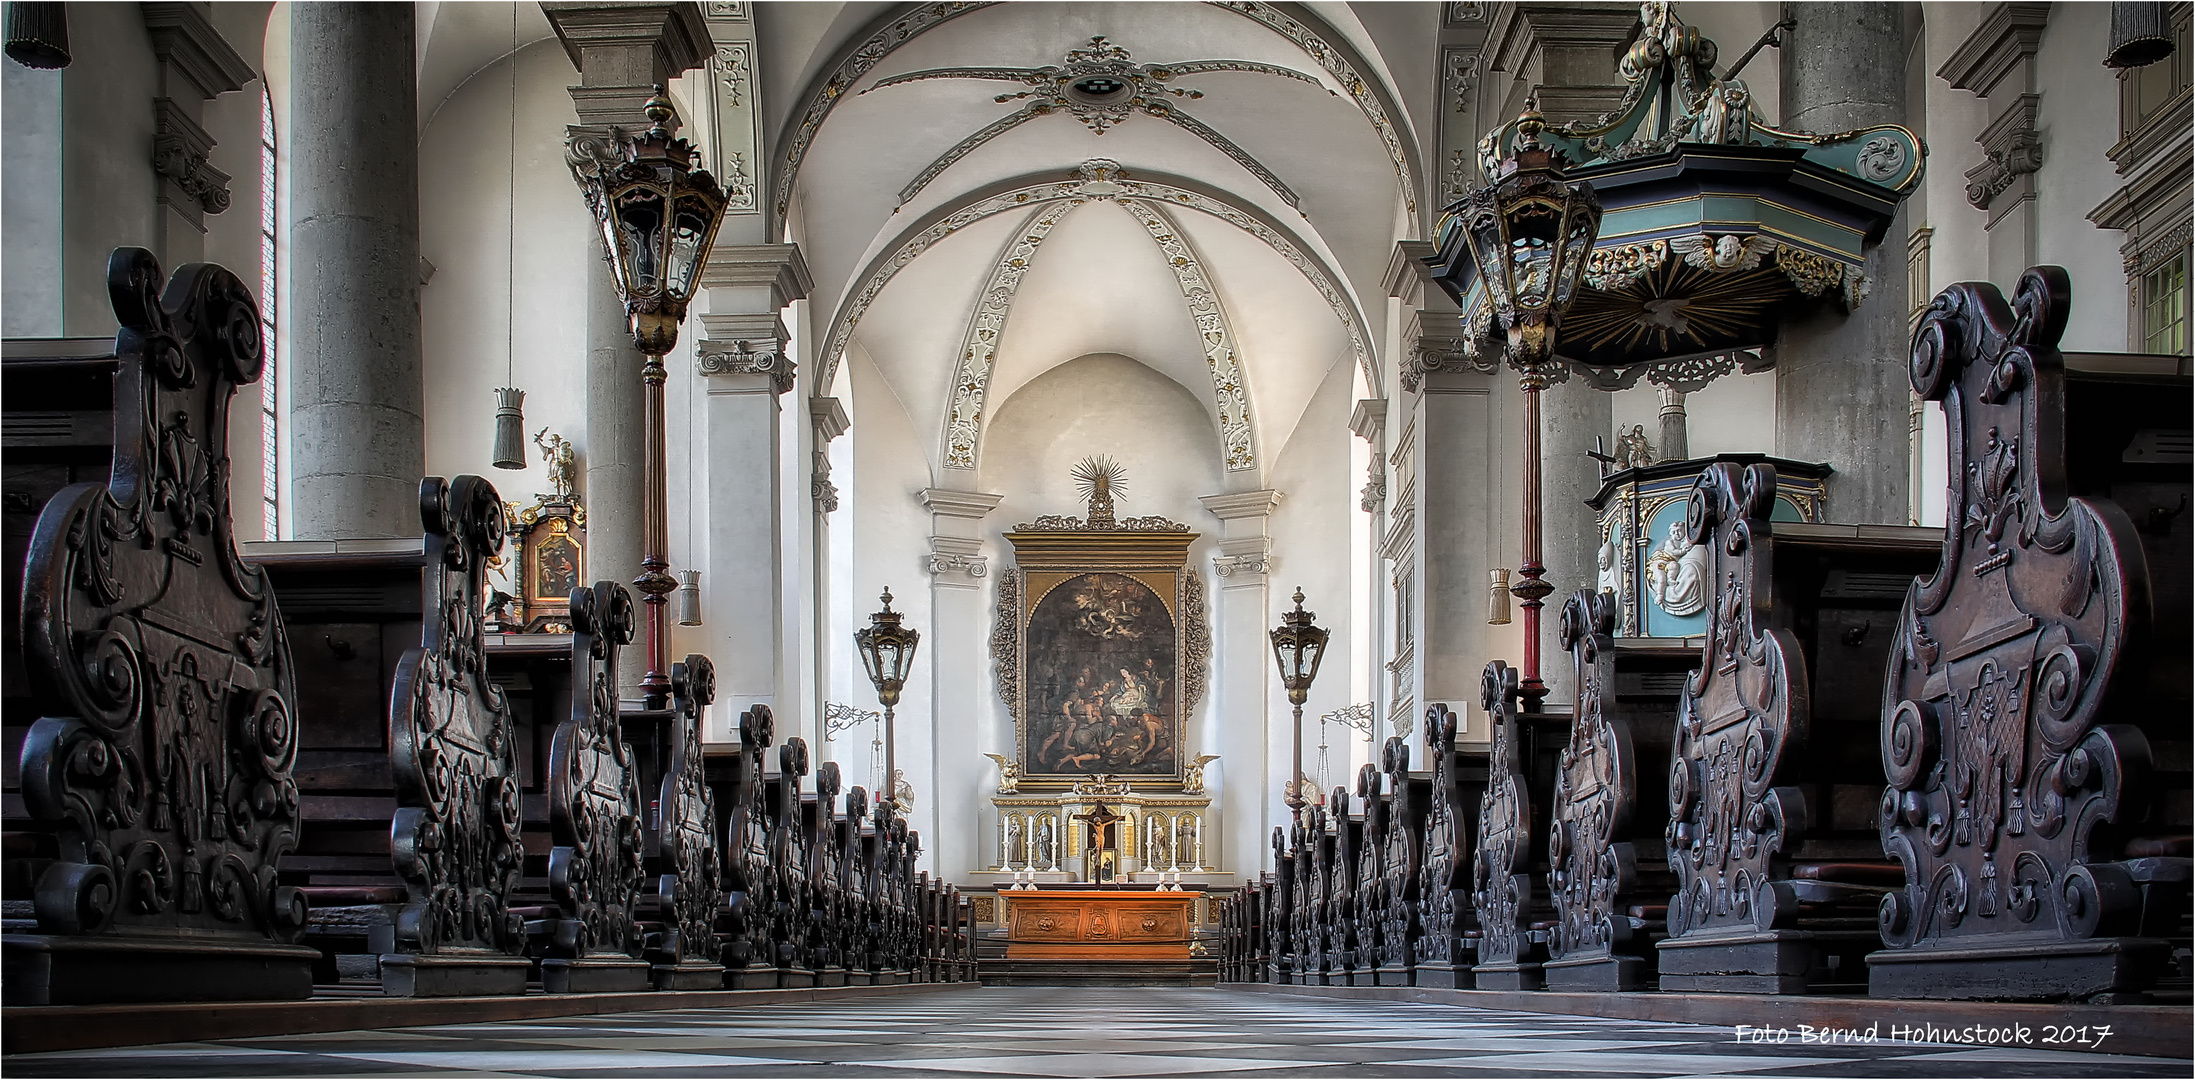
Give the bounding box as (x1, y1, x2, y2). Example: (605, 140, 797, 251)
(1666, 461, 1813, 937)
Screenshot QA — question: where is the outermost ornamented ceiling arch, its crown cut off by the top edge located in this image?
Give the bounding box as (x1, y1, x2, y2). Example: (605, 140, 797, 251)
(770, 0, 1418, 220)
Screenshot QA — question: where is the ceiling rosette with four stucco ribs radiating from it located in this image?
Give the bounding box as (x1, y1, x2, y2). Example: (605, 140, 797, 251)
(863, 35, 1319, 206)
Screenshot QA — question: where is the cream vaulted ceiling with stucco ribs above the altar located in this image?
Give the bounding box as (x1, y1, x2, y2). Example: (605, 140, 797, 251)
(757, 2, 1438, 479)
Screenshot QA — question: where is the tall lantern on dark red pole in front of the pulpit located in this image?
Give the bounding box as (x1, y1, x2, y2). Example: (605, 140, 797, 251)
(1462, 101, 1600, 705)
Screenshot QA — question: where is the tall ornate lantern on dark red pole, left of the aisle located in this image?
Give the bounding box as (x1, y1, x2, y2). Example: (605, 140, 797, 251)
(571, 86, 724, 709)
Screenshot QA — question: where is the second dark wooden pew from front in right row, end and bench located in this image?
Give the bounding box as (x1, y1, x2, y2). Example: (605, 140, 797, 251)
(1657, 463, 1936, 994)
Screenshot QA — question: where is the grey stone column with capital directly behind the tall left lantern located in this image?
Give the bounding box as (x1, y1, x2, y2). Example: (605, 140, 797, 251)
(542, 2, 706, 693)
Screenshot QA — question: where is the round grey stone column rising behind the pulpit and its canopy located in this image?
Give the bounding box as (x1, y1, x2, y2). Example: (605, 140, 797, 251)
(1776, 2, 1912, 525)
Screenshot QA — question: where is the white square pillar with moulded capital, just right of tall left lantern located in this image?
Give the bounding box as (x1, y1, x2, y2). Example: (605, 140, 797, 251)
(694, 244, 821, 746)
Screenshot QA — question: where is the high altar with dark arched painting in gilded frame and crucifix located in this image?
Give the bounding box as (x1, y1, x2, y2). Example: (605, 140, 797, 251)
(979, 459, 1227, 900)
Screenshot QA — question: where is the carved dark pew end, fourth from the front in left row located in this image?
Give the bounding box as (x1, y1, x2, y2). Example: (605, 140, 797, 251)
(648, 652, 724, 990)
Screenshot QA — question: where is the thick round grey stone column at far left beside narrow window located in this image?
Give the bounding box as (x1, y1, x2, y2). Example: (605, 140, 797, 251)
(290, 2, 426, 540)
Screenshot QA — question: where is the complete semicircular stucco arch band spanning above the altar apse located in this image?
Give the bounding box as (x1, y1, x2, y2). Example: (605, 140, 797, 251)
(819, 162, 1381, 410)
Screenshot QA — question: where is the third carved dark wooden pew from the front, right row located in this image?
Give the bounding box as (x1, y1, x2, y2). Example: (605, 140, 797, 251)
(1541, 590, 1675, 990)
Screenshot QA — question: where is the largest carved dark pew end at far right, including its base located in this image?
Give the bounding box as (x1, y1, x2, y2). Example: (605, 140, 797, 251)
(1868, 266, 2186, 999)
